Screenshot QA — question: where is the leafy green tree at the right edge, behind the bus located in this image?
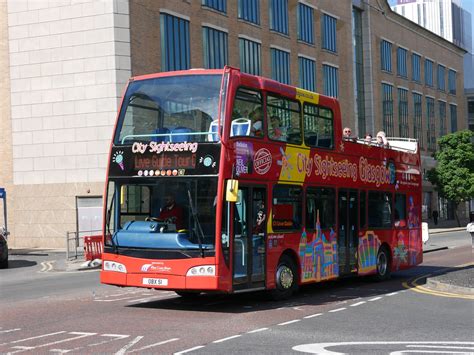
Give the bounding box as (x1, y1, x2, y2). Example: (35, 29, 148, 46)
(428, 130, 474, 226)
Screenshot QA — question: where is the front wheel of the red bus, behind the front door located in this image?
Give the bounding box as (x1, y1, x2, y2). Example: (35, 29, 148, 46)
(271, 255, 298, 301)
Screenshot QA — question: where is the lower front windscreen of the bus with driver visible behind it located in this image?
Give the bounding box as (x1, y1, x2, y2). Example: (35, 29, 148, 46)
(106, 177, 217, 249)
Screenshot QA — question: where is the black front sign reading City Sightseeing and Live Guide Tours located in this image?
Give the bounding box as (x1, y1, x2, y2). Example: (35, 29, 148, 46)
(110, 142, 220, 177)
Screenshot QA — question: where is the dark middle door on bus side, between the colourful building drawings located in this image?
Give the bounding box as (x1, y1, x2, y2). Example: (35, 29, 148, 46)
(337, 189, 358, 276)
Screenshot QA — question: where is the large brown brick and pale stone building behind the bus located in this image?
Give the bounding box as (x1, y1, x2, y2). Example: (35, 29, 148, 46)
(0, 0, 466, 247)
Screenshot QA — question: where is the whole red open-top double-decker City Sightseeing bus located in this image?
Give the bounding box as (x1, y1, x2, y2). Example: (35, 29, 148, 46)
(101, 67, 423, 298)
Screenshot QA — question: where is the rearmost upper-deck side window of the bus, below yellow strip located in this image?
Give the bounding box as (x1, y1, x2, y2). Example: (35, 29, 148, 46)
(303, 103, 334, 148)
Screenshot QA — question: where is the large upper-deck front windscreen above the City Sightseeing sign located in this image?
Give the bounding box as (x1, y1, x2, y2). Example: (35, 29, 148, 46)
(114, 74, 222, 145)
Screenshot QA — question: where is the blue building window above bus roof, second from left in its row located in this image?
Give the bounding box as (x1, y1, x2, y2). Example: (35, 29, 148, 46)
(202, 27, 228, 69)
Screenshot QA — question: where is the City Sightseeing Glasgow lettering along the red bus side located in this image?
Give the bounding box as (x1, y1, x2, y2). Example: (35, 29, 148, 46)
(297, 153, 390, 187)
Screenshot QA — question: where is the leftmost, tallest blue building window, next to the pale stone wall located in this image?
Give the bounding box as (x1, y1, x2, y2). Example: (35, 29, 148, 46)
(160, 13, 191, 71)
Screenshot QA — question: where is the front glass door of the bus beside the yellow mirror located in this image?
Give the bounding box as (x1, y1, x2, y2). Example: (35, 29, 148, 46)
(233, 186, 267, 291)
